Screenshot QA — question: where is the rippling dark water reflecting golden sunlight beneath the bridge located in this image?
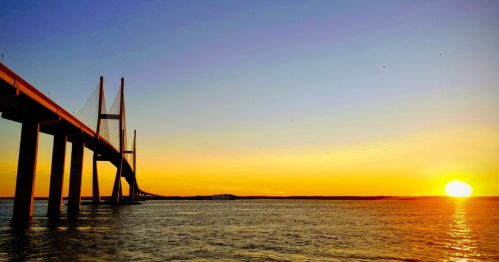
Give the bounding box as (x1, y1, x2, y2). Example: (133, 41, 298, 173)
(0, 200, 499, 261)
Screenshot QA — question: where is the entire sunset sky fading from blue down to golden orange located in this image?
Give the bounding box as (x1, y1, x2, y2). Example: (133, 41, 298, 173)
(0, 0, 499, 197)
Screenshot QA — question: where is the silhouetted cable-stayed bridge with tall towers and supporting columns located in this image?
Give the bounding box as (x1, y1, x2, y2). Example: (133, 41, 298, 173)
(0, 64, 162, 218)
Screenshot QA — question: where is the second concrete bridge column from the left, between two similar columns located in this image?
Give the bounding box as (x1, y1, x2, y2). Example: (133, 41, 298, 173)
(48, 135, 67, 215)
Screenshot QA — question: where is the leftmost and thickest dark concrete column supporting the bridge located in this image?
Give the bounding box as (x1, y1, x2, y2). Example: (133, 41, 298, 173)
(14, 122, 40, 219)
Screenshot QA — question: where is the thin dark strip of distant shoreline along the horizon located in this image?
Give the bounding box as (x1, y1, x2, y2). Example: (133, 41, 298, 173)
(0, 195, 499, 201)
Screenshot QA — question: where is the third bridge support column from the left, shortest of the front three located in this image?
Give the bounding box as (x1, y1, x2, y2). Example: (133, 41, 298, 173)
(68, 142, 85, 211)
